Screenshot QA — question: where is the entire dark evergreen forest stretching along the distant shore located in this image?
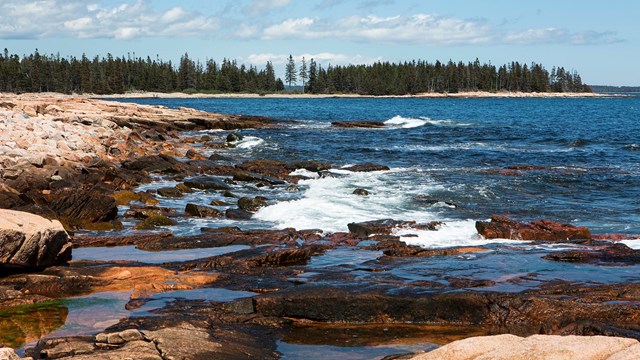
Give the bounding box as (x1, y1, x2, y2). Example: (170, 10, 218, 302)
(0, 49, 591, 95)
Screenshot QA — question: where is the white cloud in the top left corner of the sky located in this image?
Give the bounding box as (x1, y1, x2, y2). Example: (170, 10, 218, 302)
(0, 0, 218, 39)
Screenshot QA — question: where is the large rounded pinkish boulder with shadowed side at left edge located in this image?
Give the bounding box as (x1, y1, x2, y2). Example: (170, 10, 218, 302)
(0, 210, 72, 270)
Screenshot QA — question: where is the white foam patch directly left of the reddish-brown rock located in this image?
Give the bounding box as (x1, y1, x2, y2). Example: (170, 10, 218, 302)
(394, 220, 523, 248)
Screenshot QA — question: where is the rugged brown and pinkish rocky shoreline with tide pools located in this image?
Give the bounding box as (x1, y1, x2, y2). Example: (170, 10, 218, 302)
(0, 94, 640, 359)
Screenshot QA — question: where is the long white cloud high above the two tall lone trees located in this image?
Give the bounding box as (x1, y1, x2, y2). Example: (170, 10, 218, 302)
(262, 14, 493, 44)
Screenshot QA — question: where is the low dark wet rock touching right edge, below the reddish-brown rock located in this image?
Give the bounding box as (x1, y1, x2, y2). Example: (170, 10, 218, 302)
(543, 244, 640, 264)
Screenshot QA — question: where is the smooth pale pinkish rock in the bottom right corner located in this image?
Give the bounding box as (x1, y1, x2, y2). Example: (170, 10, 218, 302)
(411, 334, 640, 360)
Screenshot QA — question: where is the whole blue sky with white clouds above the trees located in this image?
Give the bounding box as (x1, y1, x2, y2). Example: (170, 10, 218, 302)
(0, 0, 640, 86)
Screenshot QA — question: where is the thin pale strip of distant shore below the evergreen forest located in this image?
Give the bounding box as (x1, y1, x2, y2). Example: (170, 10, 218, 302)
(94, 91, 627, 99)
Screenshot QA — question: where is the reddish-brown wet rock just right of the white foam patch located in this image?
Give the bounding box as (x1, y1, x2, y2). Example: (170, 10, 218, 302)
(476, 215, 591, 242)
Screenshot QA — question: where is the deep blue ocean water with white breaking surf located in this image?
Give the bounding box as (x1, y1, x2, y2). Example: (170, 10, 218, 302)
(117, 97, 640, 236)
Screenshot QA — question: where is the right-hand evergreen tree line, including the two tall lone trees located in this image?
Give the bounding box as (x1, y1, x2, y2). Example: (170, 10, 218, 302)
(285, 56, 591, 95)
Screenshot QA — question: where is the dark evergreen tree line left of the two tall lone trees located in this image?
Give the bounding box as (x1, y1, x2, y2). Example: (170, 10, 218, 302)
(0, 49, 284, 94)
